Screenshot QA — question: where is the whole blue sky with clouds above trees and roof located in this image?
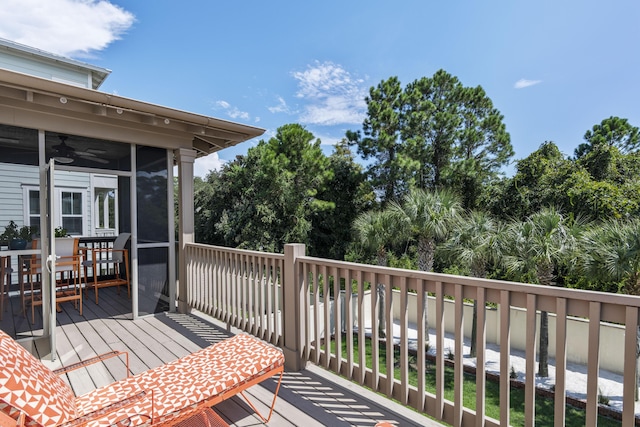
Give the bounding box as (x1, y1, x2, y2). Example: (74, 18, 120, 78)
(0, 0, 640, 176)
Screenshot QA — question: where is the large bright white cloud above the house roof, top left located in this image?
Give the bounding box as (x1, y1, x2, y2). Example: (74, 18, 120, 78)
(0, 0, 135, 56)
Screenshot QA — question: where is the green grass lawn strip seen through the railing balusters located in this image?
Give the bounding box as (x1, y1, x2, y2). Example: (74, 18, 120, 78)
(331, 335, 622, 427)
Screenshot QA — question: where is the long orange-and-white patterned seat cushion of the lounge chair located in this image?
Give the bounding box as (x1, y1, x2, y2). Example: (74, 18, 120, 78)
(76, 334, 284, 426)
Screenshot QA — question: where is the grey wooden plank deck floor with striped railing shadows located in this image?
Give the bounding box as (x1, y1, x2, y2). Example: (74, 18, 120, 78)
(0, 288, 441, 427)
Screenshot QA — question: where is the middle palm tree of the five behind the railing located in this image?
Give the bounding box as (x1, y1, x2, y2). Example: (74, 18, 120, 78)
(443, 211, 505, 357)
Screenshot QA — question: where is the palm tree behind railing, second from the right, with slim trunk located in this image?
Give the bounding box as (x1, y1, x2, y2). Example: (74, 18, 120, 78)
(503, 208, 581, 377)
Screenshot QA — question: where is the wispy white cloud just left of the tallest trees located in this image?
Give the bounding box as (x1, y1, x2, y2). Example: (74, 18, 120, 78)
(292, 62, 367, 126)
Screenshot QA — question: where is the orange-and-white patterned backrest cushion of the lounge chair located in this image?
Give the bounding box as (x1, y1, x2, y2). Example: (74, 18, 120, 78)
(0, 331, 77, 427)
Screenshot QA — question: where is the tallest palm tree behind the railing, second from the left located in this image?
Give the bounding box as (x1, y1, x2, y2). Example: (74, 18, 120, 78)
(387, 189, 462, 341)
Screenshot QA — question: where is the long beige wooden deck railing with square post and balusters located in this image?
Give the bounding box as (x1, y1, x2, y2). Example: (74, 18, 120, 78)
(181, 244, 640, 426)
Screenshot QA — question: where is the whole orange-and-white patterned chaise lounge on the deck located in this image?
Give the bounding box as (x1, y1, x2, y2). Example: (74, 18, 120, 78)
(0, 331, 284, 427)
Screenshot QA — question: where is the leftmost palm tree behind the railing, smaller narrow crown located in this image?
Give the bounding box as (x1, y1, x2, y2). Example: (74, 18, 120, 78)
(353, 211, 397, 338)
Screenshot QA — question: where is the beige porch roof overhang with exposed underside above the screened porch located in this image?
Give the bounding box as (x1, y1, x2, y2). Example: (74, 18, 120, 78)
(0, 69, 264, 157)
